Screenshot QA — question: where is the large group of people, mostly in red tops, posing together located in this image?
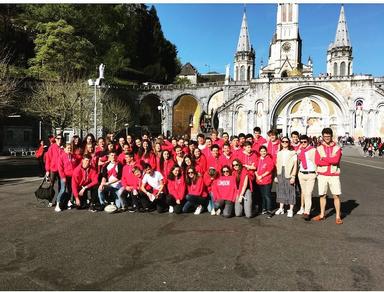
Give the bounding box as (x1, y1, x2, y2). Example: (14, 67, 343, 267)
(42, 127, 343, 224)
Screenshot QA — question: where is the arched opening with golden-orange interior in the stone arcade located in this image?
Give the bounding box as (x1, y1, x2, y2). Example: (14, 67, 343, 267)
(172, 94, 201, 137)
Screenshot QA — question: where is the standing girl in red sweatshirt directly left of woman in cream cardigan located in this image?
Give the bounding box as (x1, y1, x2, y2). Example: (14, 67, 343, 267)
(256, 146, 275, 218)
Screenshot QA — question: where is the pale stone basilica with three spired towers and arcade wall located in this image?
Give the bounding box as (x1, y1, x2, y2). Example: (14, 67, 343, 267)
(135, 3, 384, 137)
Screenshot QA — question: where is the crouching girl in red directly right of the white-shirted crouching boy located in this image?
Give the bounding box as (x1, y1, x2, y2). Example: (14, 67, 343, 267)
(165, 164, 186, 214)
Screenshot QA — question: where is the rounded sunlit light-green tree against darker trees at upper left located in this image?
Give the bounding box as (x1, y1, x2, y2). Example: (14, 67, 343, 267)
(29, 20, 93, 79)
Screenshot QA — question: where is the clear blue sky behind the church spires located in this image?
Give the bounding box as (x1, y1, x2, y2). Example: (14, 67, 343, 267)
(154, 3, 384, 77)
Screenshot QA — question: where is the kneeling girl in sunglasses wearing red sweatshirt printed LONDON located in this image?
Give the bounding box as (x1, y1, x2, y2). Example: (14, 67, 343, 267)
(212, 165, 237, 218)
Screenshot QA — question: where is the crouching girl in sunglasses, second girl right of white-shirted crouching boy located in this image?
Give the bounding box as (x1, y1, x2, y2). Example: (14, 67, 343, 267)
(183, 167, 207, 215)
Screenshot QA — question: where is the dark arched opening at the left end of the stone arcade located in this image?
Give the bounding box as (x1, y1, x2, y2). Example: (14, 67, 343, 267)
(139, 94, 161, 135)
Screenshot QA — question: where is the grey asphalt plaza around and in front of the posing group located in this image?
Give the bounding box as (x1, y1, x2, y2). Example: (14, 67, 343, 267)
(0, 146, 384, 290)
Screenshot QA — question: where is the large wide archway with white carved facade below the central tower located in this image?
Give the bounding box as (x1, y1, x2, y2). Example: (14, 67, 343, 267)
(270, 87, 348, 136)
